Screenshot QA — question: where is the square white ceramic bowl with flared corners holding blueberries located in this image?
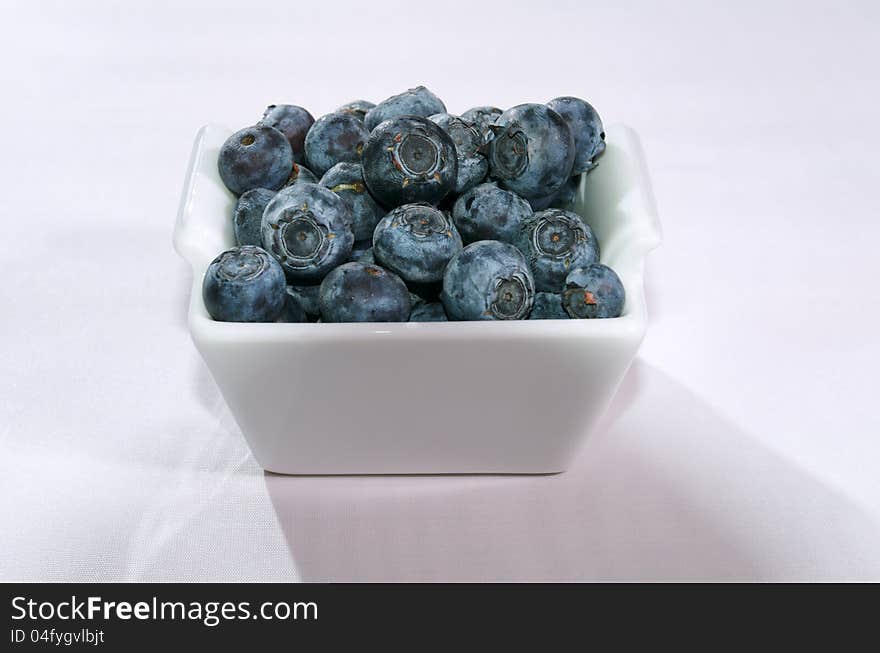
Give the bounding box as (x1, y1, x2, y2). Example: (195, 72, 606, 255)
(174, 125, 660, 474)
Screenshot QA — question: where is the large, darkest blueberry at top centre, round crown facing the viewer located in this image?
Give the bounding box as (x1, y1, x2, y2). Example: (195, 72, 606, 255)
(363, 116, 458, 208)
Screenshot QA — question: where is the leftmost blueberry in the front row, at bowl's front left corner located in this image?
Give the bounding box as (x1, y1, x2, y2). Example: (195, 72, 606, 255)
(202, 245, 285, 322)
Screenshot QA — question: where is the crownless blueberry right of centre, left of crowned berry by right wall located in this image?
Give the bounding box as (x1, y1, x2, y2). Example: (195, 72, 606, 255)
(452, 184, 532, 244)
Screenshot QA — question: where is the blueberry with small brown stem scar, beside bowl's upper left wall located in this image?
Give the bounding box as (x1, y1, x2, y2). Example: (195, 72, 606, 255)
(217, 125, 293, 195)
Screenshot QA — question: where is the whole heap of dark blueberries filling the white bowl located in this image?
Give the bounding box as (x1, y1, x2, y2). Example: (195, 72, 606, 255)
(203, 86, 624, 322)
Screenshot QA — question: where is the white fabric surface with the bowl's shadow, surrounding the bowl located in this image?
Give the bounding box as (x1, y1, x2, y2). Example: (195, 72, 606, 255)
(0, 0, 880, 581)
